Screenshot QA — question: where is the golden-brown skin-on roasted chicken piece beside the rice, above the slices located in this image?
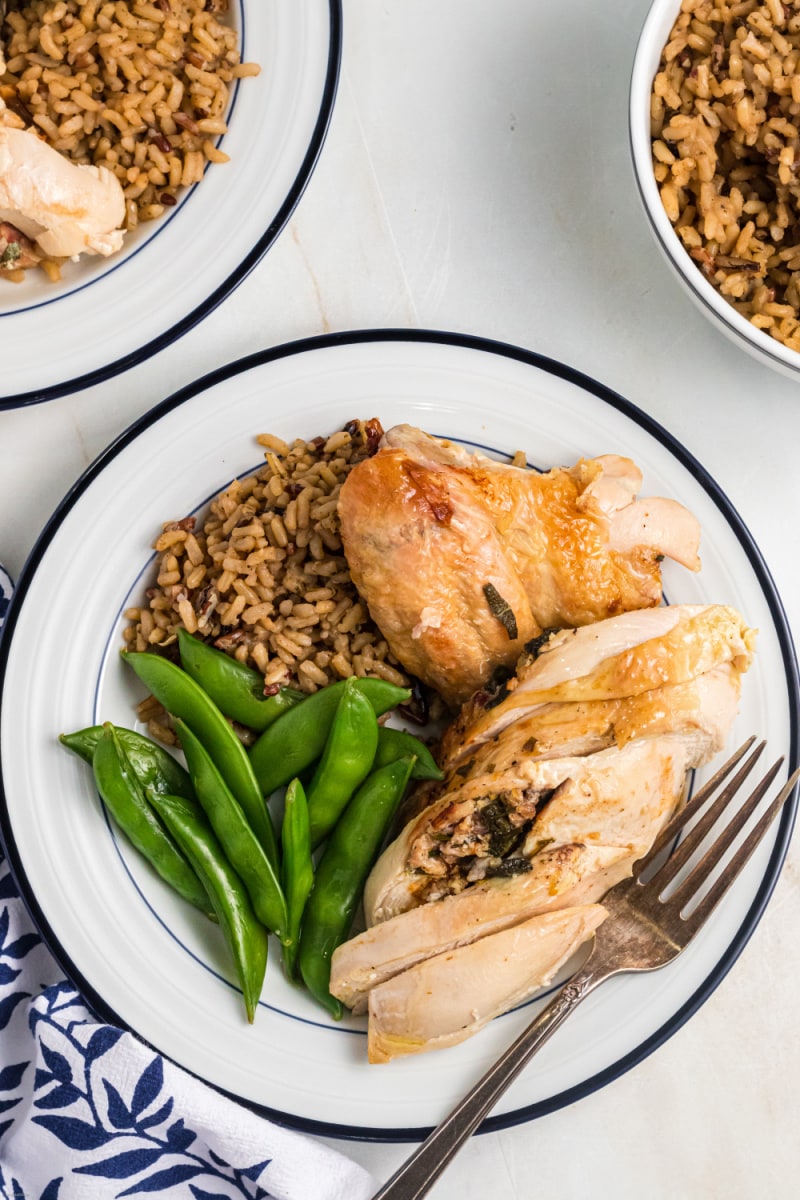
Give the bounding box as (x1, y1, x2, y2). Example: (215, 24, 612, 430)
(338, 425, 699, 706)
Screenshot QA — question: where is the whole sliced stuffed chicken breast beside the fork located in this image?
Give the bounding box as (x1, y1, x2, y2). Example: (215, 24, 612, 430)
(331, 606, 754, 1062)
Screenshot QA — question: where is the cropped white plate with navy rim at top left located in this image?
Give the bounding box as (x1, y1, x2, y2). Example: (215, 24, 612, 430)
(0, 0, 342, 409)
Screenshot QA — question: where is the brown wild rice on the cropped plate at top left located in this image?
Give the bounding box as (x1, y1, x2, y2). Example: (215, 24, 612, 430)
(0, 0, 259, 278)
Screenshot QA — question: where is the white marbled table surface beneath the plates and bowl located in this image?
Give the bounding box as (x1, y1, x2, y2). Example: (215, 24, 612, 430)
(0, 0, 800, 1200)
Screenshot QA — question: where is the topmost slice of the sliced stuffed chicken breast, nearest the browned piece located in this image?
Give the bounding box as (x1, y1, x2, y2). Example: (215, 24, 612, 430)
(438, 605, 756, 769)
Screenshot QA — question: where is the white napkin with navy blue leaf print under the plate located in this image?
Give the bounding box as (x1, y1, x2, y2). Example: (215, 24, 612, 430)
(0, 566, 377, 1200)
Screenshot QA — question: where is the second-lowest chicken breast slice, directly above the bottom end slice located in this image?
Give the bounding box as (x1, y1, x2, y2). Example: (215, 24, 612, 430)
(330, 842, 632, 1013)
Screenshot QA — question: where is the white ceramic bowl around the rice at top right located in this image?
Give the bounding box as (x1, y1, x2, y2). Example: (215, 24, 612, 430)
(628, 0, 800, 379)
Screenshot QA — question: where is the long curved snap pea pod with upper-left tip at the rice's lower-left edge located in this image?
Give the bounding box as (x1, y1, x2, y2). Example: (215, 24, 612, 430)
(122, 650, 280, 866)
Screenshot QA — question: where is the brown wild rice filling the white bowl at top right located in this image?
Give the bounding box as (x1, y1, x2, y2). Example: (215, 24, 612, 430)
(651, 0, 800, 350)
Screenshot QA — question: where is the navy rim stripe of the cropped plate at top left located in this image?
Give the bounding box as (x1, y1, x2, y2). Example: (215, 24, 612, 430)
(0, 0, 342, 412)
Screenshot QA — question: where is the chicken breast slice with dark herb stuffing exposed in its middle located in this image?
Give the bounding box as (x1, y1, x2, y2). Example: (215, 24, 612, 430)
(363, 734, 695, 926)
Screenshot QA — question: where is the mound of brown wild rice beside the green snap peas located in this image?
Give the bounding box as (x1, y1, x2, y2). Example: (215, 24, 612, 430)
(124, 420, 409, 740)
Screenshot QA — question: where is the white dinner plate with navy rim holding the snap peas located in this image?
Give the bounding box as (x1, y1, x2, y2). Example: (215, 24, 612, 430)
(0, 330, 800, 1140)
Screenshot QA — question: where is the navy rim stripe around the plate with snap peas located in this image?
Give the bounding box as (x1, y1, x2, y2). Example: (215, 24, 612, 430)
(0, 329, 800, 1142)
